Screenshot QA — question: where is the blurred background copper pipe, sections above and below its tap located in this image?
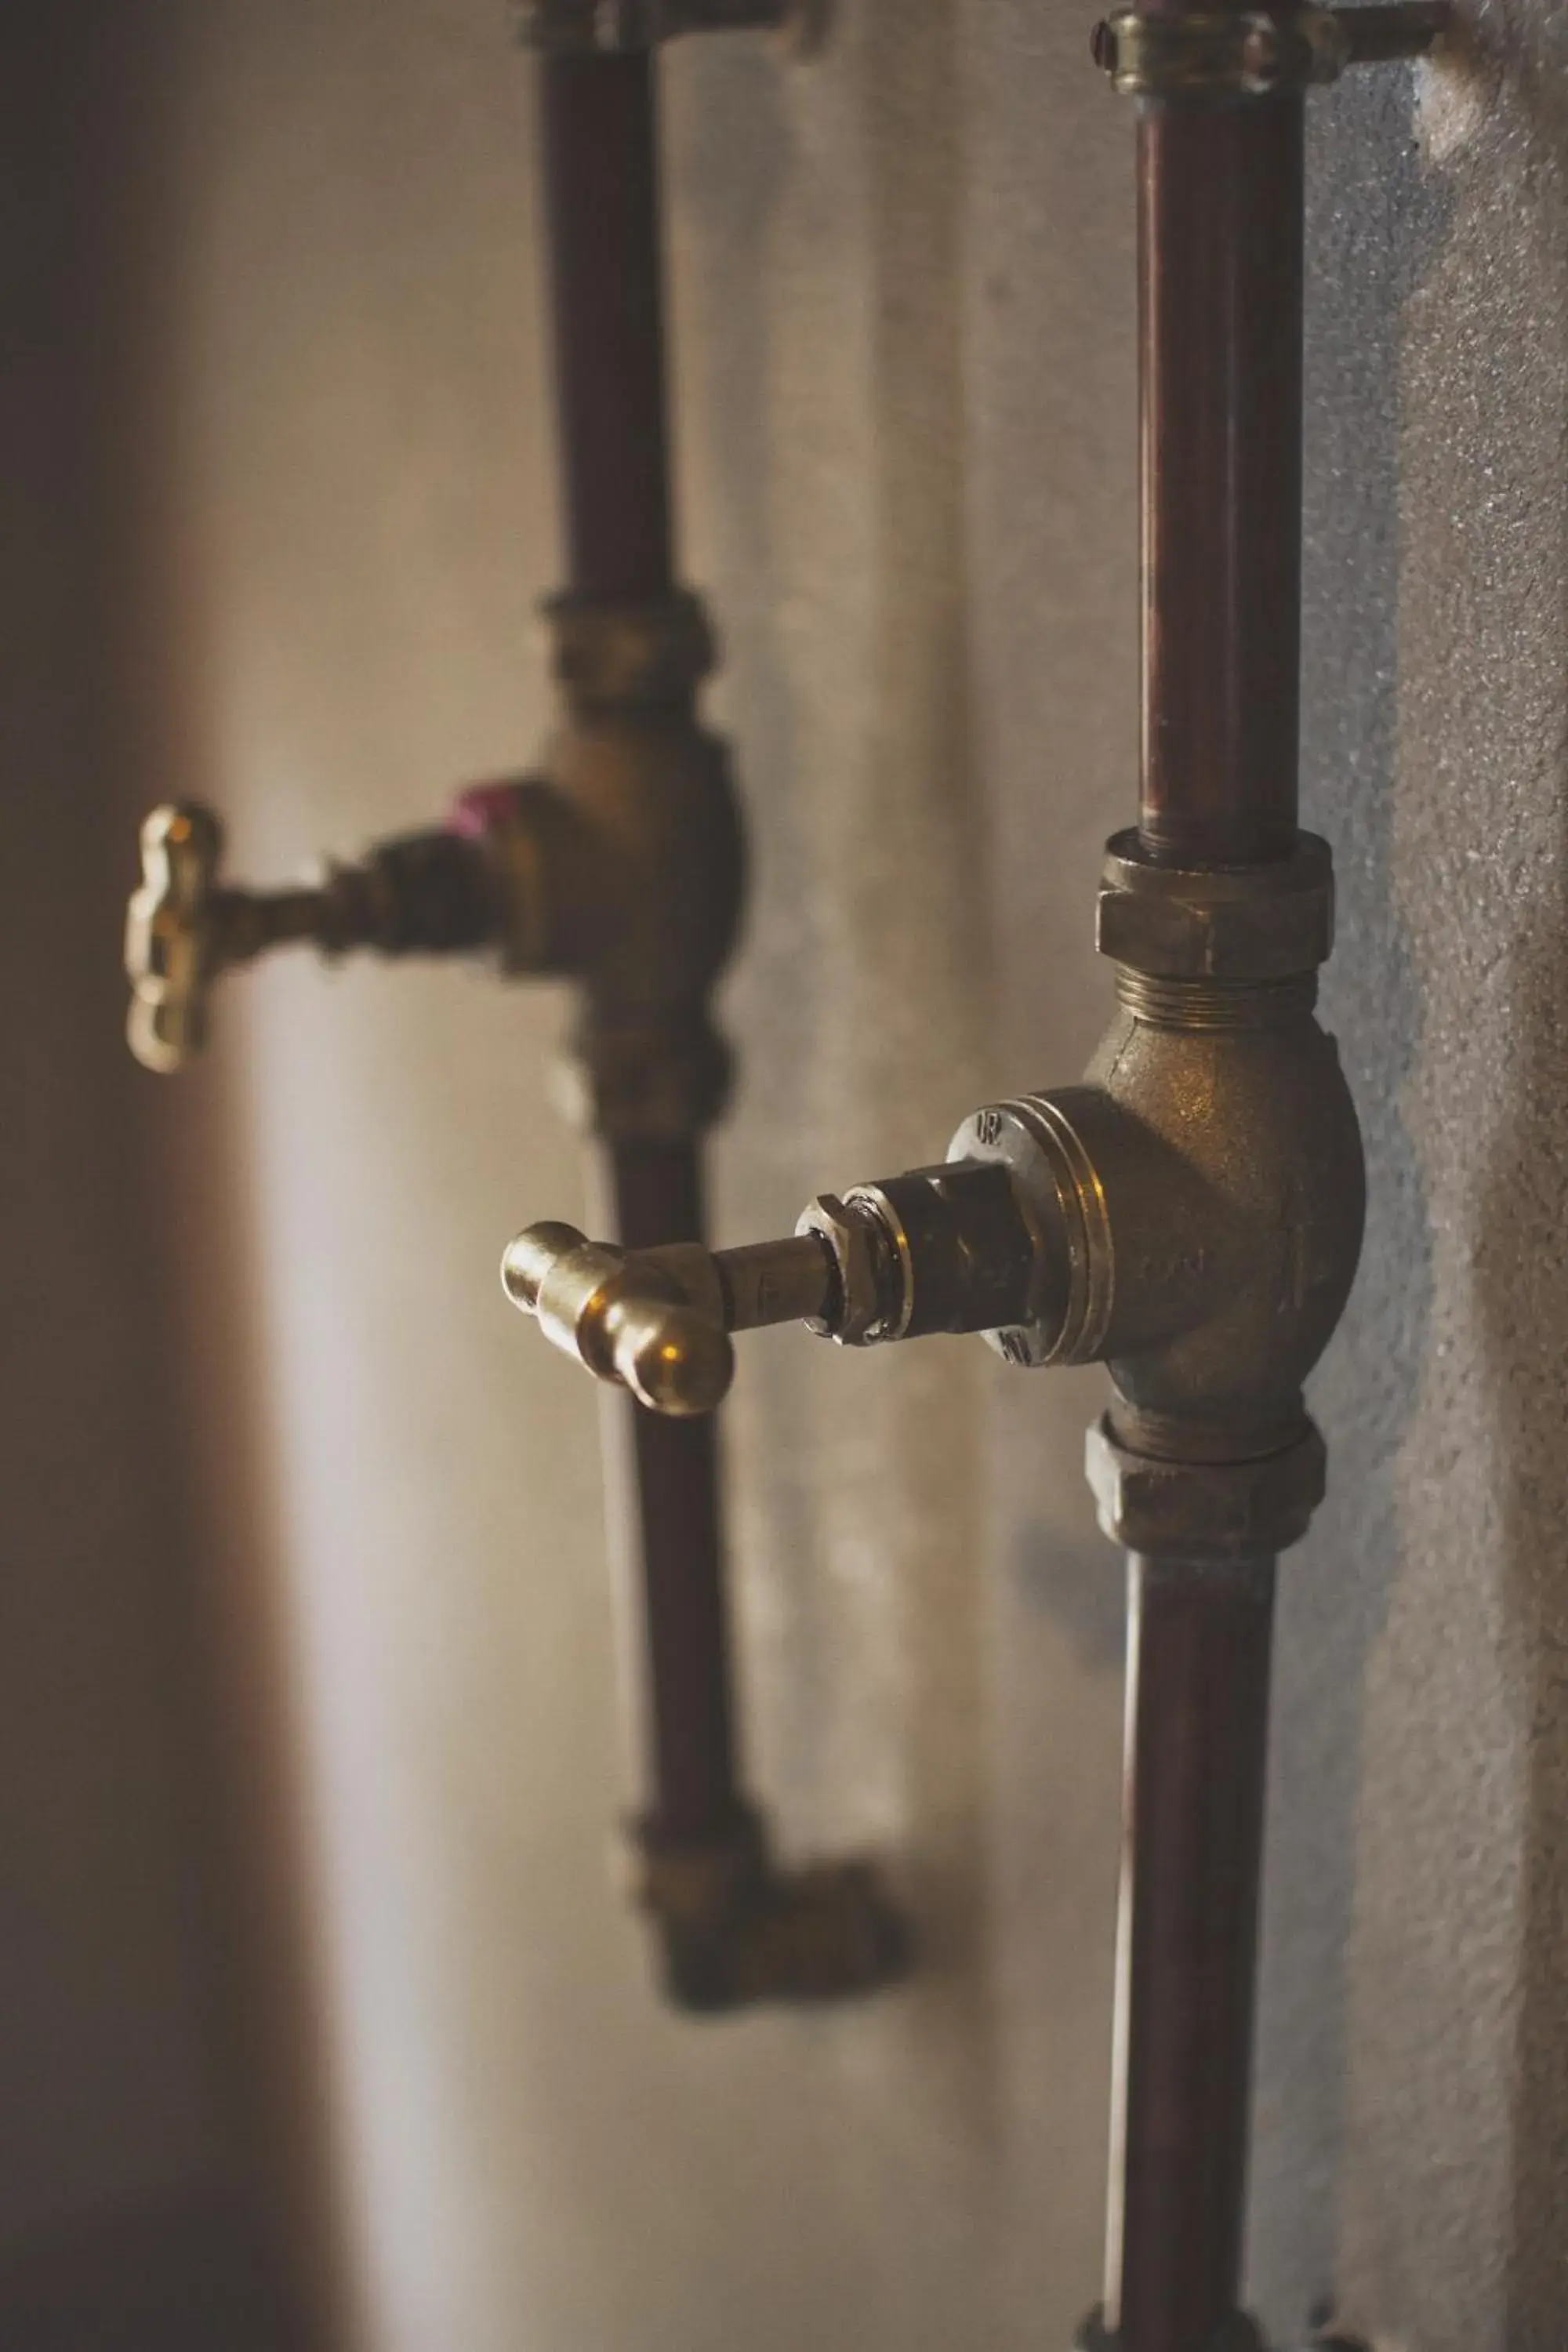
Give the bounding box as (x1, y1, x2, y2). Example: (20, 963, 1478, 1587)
(541, 56, 746, 1842)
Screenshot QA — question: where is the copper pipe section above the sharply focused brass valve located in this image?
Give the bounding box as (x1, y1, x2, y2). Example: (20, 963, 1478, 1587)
(1138, 96, 1305, 866)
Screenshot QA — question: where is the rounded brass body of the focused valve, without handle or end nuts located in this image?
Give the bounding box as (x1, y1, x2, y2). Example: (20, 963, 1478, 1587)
(952, 971, 1363, 1451)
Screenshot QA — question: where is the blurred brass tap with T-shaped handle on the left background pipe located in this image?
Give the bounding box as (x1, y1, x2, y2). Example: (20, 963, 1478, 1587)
(125, 595, 743, 1143)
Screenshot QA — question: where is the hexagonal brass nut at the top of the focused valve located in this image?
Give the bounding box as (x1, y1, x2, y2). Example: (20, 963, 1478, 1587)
(1095, 833, 1333, 981)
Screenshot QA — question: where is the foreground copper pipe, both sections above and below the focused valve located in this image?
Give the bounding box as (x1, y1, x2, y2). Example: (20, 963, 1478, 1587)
(1105, 0, 1305, 2352)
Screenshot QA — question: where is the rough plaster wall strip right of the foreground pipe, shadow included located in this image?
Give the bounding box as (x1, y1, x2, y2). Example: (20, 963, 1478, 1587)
(1255, 9, 1568, 2352)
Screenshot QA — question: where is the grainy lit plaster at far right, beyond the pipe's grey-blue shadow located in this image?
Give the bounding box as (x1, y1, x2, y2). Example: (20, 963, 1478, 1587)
(1345, 23, 1568, 2352)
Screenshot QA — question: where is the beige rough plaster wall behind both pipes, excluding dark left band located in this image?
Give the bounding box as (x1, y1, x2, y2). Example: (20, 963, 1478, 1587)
(162, 0, 1568, 2352)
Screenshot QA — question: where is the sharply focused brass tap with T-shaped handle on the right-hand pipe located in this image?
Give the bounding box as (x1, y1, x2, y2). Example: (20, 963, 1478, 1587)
(503, 837, 1363, 1557)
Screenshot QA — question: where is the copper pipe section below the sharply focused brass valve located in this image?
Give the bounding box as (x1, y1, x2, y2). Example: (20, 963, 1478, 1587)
(1107, 1557, 1274, 2352)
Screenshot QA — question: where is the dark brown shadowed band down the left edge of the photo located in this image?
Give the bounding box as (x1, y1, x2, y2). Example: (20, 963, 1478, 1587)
(0, 0, 340, 2352)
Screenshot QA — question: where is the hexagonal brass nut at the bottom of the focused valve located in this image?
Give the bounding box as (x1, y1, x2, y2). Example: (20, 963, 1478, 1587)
(1083, 1416, 1328, 1559)
